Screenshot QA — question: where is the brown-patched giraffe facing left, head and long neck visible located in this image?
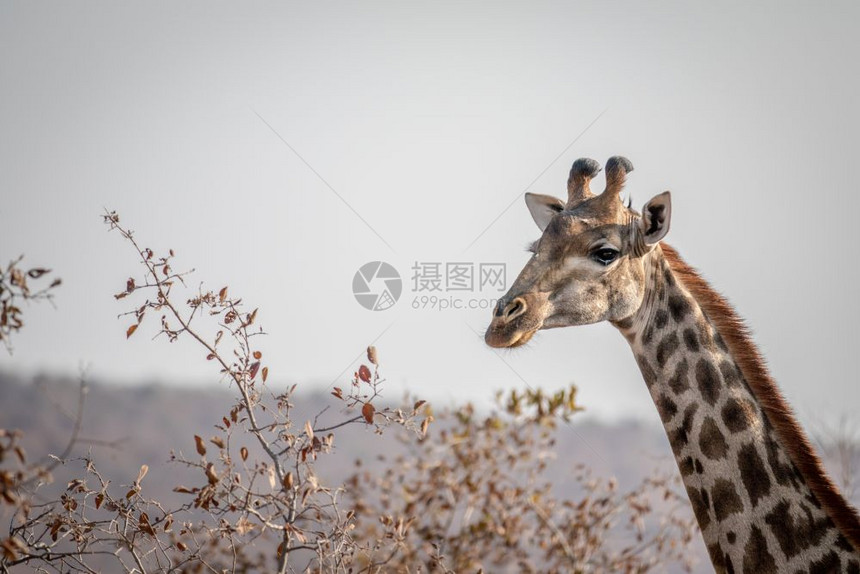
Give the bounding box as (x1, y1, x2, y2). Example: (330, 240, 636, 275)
(485, 156, 860, 574)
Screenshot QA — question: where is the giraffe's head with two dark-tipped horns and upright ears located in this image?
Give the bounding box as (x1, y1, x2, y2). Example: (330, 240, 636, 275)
(485, 156, 671, 347)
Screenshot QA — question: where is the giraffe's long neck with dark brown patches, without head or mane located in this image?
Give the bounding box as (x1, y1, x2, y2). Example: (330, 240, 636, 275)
(616, 247, 860, 573)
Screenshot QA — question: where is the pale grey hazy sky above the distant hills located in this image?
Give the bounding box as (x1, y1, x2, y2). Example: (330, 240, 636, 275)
(0, 2, 860, 430)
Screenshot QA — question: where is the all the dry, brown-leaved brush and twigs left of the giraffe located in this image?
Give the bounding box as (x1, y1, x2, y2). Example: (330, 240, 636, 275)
(0, 213, 695, 573)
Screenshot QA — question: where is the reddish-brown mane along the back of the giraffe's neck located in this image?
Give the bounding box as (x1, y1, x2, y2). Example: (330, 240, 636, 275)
(660, 243, 860, 551)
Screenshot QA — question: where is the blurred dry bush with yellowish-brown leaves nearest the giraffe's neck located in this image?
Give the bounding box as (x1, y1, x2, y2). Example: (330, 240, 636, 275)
(347, 388, 697, 572)
